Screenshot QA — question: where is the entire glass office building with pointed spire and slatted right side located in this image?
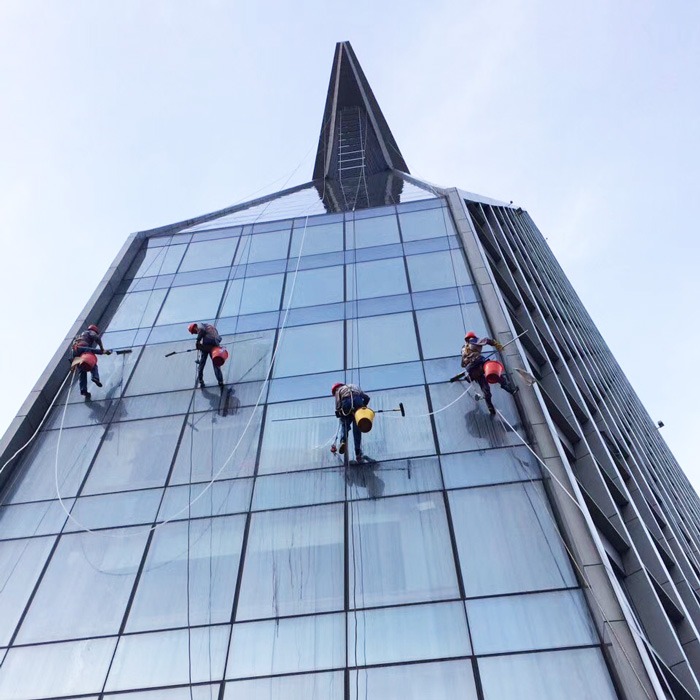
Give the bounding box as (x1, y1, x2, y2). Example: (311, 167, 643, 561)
(0, 43, 700, 700)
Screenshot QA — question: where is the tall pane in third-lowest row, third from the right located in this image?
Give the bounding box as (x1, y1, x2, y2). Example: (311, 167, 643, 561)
(236, 505, 344, 621)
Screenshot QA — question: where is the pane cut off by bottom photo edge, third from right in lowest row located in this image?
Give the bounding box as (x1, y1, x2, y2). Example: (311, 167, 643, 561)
(224, 672, 345, 700)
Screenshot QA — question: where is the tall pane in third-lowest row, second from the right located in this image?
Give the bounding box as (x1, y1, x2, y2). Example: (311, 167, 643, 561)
(349, 494, 459, 607)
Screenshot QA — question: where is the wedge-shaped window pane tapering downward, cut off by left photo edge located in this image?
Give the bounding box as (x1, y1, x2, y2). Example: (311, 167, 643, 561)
(0, 537, 56, 644)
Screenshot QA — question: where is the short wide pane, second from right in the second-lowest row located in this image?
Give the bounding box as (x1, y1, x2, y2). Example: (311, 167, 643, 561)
(348, 603, 471, 666)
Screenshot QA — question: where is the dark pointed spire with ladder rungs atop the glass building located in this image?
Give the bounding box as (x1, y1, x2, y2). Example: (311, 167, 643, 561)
(313, 41, 409, 210)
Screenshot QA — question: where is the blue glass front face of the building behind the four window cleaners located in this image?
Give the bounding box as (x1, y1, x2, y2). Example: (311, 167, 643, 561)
(0, 194, 617, 700)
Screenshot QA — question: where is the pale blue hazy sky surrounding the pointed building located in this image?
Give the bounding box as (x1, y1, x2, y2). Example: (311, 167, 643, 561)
(0, 0, 700, 488)
